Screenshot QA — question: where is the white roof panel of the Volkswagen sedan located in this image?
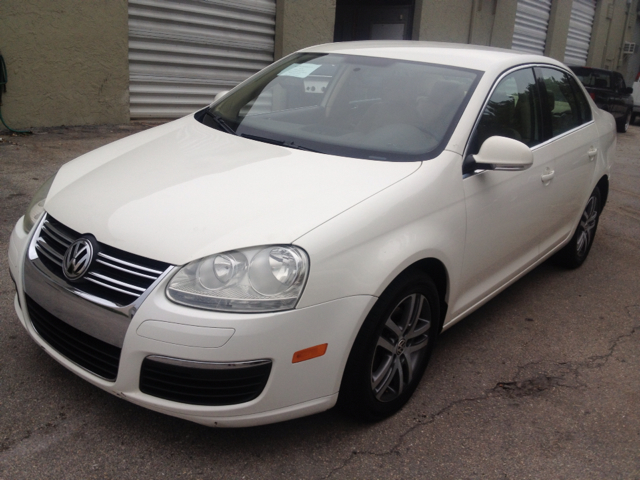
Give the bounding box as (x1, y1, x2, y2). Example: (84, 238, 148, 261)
(301, 40, 567, 72)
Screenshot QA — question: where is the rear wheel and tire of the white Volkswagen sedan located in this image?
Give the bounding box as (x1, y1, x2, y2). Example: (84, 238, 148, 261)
(554, 187, 602, 268)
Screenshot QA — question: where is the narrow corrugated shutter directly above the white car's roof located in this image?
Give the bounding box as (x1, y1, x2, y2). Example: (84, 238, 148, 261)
(511, 0, 551, 55)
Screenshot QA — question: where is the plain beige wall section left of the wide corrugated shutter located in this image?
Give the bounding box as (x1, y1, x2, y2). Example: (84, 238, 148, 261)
(0, 0, 129, 130)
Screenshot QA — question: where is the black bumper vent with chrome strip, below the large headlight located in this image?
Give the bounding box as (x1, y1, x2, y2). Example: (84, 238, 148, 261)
(140, 358, 271, 406)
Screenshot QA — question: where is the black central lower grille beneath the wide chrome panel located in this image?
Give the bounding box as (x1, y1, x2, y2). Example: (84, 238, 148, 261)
(27, 296, 120, 381)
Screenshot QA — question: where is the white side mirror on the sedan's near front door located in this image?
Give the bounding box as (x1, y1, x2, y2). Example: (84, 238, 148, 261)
(465, 136, 533, 171)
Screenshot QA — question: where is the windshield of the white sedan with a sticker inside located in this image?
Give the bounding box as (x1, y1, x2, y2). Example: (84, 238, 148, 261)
(197, 53, 481, 161)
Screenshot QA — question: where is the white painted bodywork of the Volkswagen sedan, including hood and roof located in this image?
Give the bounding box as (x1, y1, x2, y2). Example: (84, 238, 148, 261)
(9, 42, 615, 426)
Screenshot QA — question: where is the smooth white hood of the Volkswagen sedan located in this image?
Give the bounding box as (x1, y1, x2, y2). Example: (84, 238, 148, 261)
(45, 116, 420, 265)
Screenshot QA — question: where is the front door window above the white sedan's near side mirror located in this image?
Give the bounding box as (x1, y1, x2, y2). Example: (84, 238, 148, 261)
(470, 68, 542, 153)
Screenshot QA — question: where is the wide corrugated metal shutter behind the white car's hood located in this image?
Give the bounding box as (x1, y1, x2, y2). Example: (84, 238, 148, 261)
(129, 0, 276, 118)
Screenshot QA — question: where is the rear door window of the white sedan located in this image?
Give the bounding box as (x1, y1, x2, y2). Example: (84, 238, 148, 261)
(540, 68, 584, 137)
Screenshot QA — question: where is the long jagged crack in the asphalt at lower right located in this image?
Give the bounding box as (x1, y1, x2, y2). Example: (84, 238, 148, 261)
(321, 305, 640, 480)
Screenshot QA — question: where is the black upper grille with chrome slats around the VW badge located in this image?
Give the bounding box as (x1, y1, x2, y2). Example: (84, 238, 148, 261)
(35, 215, 170, 306)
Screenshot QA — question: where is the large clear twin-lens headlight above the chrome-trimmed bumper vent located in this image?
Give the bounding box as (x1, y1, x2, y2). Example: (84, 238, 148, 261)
(167, 245, 309, 313)
